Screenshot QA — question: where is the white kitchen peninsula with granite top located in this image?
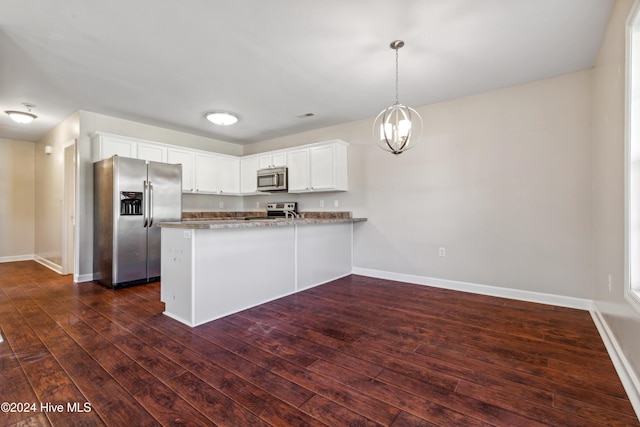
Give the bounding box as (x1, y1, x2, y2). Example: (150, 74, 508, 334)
(159, 212, 366, 326)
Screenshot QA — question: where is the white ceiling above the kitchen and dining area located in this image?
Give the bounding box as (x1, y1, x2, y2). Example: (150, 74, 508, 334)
(0, 0, 614, 143)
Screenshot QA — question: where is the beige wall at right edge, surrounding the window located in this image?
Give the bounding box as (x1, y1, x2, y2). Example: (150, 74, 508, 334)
(591, 0, 640, 393)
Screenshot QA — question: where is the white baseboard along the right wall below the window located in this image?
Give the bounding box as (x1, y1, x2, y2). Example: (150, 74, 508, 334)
(589, 303, 640, 419)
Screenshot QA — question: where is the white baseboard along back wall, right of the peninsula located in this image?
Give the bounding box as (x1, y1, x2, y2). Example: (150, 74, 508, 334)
(352, 267, 591, 310)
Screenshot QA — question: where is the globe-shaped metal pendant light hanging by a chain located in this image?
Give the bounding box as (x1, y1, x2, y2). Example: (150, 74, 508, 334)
(373, 40, 422, 155)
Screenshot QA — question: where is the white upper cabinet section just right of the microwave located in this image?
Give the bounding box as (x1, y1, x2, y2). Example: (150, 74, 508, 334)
(287, 140, 348, 193)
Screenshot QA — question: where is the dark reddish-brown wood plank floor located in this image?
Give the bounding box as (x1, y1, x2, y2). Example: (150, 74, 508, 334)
(0, 262, 640, 427)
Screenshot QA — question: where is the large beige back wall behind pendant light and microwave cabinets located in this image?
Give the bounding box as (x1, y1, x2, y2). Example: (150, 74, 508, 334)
(245, 71, 592, 298)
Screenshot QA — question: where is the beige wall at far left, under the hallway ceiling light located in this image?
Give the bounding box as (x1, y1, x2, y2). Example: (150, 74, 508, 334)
(0, 139, 35, 262)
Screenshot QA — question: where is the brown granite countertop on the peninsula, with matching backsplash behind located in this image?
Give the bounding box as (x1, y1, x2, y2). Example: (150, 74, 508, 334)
(158, 212, 367, 229)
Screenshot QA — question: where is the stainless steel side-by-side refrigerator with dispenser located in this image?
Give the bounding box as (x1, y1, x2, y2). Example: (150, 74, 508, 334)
(93, 156, 182, 289)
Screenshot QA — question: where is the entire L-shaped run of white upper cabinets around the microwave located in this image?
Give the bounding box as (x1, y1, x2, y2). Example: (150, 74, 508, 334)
(92, 132, 349, 195)
